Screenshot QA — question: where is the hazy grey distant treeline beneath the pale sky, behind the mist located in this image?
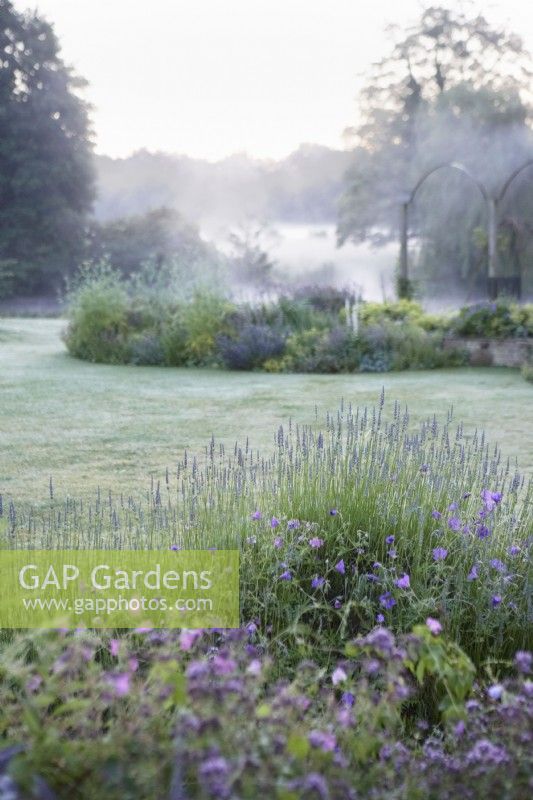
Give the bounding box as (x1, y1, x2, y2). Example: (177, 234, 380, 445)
(95, 144, 352, 224)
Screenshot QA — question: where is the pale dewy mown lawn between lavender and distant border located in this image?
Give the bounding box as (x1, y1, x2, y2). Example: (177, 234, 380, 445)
(0, 319, 533, 504)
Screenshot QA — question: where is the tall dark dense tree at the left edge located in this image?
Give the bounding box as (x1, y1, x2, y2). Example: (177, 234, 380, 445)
(0, 0, 93, 295)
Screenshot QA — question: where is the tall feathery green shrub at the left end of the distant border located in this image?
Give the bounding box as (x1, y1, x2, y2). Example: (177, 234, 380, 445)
(64, 264, 129, 364)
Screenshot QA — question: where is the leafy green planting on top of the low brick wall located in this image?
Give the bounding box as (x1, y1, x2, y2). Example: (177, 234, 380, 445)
(451, 299, 533, 339)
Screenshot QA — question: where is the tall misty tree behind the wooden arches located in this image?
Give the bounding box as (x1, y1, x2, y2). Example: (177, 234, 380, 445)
(338, 7, 533, 290)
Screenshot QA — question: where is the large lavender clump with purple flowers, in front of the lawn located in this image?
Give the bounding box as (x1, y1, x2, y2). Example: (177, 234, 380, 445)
(0, 397, 533, 664)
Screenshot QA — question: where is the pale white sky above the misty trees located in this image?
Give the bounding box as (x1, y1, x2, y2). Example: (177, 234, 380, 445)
(23, 0, 533, 160)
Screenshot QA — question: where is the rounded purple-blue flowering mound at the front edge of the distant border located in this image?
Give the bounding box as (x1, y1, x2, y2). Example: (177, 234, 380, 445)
(217, 324, 285, 369)
